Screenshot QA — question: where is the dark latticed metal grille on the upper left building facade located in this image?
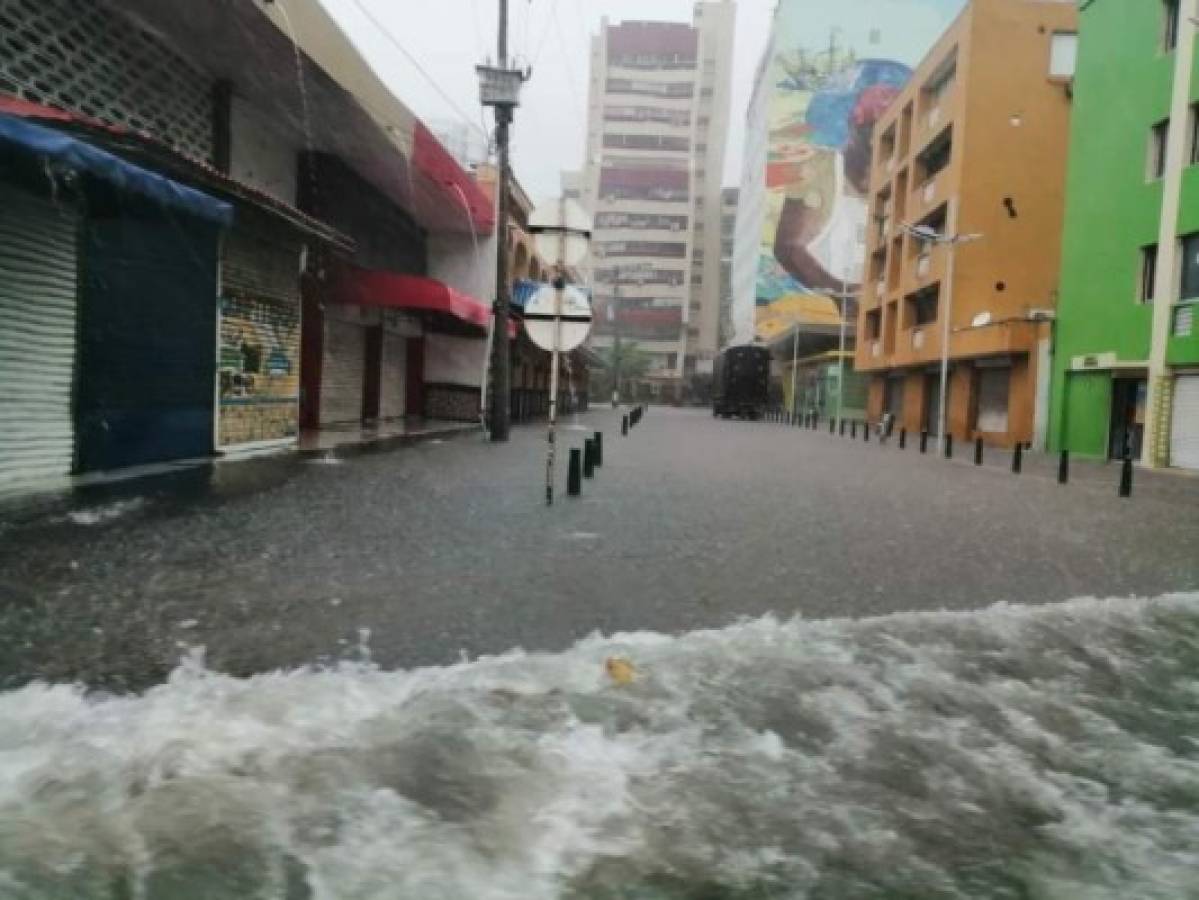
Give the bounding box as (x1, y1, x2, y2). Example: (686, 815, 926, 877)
(0, 0, 212, 159)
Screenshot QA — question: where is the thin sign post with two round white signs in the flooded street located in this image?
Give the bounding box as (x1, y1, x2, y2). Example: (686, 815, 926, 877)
(525, 198, 591, 506)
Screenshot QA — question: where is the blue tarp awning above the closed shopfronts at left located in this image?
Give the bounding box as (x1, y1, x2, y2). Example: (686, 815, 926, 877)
(0, 115, 234, 228)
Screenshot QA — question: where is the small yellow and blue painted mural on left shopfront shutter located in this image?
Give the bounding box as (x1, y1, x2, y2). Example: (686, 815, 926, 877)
(217, 296, 300, 446)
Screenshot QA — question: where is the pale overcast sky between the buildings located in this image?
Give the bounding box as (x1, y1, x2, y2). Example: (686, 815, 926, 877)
(321, 0, 775, 200)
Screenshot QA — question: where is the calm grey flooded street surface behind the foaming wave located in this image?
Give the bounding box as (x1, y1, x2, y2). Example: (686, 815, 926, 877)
(7, 407, 1199, 690)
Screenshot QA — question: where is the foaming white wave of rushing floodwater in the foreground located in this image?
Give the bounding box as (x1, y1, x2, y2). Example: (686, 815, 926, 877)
(0, 596, 1199, 900)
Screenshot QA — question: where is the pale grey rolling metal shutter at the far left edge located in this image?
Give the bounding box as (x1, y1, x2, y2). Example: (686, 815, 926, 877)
(0, 186, 79, 494)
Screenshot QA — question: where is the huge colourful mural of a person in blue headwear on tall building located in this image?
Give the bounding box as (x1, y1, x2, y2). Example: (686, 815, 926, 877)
(754, 0, 964, 337)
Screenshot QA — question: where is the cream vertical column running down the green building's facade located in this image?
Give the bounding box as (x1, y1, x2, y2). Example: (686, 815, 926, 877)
(1141, 0, 1199, 469)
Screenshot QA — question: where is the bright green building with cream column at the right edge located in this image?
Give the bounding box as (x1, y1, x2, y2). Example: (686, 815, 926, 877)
(1049, 0, 1199, 469)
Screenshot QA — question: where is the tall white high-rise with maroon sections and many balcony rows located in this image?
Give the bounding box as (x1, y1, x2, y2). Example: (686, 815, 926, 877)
(580, 0, 735, 398)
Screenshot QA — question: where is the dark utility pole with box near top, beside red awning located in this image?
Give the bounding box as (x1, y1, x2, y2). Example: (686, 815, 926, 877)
(475, 0, 525, 441)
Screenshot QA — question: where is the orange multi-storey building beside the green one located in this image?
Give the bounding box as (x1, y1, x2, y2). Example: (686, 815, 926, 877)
(856, 0, 1077, 446)
